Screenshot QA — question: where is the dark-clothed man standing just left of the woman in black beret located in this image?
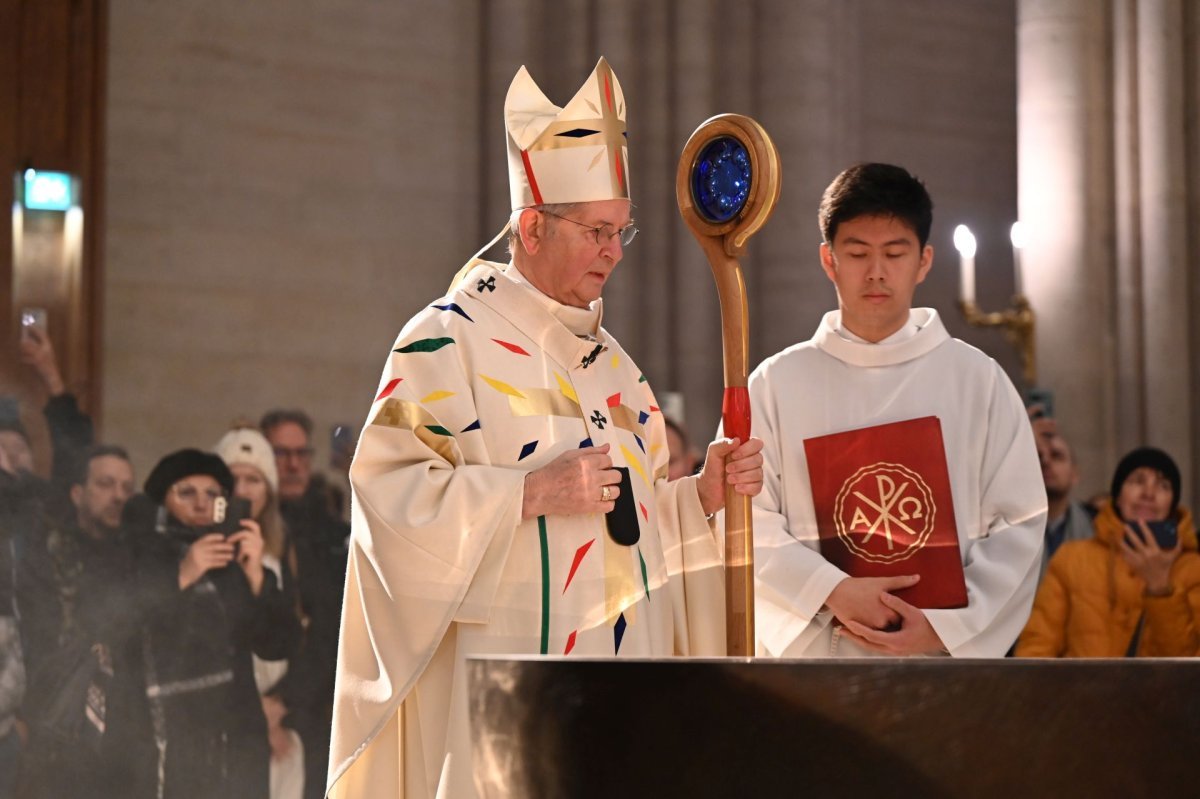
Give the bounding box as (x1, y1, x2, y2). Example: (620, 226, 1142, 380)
(16, 445, 145, 799)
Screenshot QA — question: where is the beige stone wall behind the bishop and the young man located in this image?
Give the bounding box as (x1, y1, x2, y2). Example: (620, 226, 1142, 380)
(102, 0, 1019, 475)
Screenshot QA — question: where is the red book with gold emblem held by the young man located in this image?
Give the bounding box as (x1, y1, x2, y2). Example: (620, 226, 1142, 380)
(804, 416, 967, 608)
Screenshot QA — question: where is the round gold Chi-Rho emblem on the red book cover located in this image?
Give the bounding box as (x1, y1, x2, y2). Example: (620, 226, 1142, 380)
(834, 462, 937, 563)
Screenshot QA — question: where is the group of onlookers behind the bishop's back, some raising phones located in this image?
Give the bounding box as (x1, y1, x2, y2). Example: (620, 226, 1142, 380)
(0, 328, 349, 799)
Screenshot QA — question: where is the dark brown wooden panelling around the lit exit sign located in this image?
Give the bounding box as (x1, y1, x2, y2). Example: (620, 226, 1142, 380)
(0, 0, 108, 471)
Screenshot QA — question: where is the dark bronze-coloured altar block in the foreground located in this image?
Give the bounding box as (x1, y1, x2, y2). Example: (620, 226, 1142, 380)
(469, 657, 1200, 799)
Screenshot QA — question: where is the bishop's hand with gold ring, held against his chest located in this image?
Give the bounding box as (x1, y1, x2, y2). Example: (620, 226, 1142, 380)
(521, 444, 620, 519)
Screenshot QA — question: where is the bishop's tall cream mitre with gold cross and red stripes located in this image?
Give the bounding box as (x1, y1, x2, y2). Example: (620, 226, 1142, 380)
(504, 58, 629, 210)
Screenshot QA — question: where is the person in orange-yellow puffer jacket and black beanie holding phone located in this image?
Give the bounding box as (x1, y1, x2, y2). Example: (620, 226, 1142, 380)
(1015, 447, 1200, 657)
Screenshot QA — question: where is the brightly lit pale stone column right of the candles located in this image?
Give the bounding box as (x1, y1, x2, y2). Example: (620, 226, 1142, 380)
(1016, 0, 1117, 491)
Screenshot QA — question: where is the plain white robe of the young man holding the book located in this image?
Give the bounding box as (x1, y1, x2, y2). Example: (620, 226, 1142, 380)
(749, 308, 1046, 657)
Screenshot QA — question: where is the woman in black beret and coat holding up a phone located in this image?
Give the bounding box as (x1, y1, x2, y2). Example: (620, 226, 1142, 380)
(127, 450, 301, 799)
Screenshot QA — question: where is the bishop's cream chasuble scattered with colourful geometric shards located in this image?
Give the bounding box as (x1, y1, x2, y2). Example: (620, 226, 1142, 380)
(330, 263, 725, 799)
